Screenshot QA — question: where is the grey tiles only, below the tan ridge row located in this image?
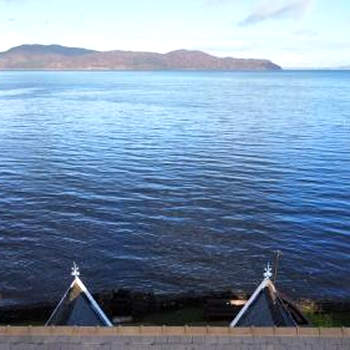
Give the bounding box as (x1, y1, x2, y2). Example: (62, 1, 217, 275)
(0, 335, 350, 350)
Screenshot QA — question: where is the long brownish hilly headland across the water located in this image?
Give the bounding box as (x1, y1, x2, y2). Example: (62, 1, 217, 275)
(0, 45, 281, 70)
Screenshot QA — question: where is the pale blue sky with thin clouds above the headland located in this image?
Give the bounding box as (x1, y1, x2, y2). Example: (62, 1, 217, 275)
(0, 0, 350, 67)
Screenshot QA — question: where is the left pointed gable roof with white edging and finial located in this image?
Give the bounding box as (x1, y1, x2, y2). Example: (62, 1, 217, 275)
(46, 265, 112, 327)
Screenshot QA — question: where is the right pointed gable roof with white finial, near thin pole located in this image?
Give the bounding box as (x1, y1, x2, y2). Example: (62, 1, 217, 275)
(230, 265, 307, 327)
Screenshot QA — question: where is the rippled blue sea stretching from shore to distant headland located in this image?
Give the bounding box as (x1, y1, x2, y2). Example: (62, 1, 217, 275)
(0, 71, 350, 303)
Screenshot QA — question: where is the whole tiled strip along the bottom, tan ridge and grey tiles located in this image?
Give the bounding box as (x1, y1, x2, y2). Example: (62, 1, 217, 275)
(0, 326, 350, 350)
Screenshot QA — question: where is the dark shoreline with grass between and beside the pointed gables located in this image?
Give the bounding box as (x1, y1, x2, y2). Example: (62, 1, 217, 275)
(0, 289, 350, 326)
